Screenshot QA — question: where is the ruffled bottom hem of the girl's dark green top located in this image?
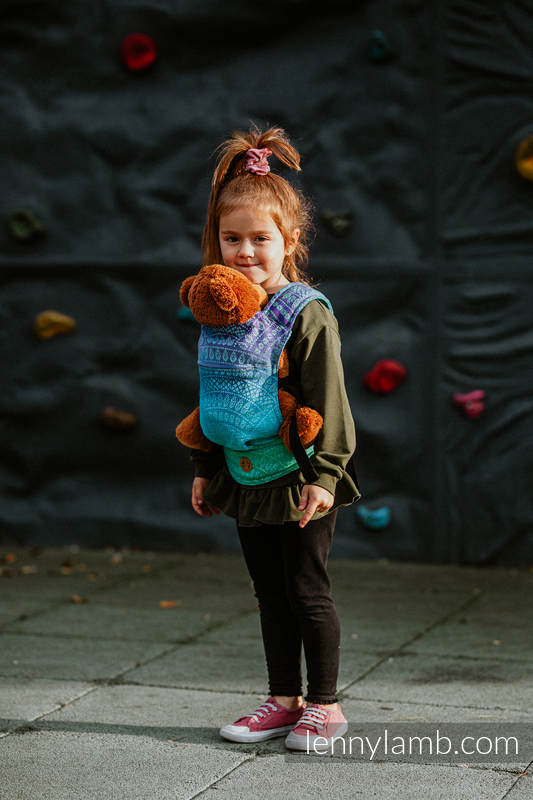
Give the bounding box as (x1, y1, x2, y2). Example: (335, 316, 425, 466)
(204, 466, 361, 527)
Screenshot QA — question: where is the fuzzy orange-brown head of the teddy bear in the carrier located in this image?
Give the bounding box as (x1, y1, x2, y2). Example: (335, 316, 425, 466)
(180, 264, 268, 327)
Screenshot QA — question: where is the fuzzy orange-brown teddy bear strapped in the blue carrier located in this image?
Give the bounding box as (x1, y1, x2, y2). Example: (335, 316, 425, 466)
(176, 264, 323, 452)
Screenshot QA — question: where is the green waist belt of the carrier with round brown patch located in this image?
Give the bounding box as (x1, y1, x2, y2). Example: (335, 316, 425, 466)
(224, 436, 315, 486)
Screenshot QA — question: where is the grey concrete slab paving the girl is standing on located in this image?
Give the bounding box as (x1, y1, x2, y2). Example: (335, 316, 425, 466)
(0, 546, 533, 800)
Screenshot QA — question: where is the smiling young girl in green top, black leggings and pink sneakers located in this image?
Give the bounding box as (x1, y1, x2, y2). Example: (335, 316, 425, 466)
(185, 128, 361, 750)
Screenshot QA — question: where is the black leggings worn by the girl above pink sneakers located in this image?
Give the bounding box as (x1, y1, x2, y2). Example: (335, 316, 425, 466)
(237, 510, 340, 703)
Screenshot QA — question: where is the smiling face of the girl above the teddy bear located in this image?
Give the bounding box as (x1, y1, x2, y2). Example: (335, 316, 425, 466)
(218, 206, 300, 292)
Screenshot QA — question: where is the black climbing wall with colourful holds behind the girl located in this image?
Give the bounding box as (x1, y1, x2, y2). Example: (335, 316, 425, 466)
(0, 0, 533, 563)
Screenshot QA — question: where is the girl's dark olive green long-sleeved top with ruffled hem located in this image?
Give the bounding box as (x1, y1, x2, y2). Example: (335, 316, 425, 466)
(190, 295, 361, 526)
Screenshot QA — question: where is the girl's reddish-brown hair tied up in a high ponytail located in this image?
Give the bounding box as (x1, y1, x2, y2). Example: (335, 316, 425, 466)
(202, 125, 312, 283)
